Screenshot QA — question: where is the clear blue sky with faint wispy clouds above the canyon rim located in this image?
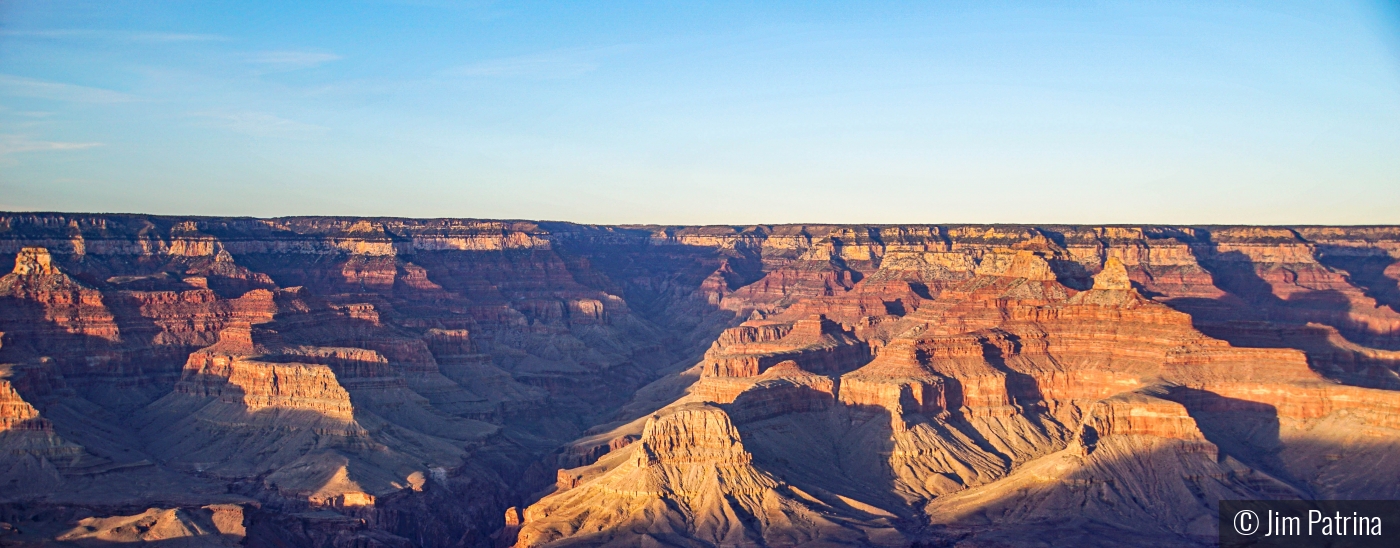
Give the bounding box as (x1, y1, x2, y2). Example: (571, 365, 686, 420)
(0, 0, 1400, 224)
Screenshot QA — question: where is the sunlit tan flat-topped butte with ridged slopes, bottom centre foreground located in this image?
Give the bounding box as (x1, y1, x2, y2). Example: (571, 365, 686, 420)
(518, 404, 899, 545)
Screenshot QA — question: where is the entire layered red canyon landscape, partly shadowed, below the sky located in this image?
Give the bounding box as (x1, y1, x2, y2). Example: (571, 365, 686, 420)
(0, 213, 1400, 548)
